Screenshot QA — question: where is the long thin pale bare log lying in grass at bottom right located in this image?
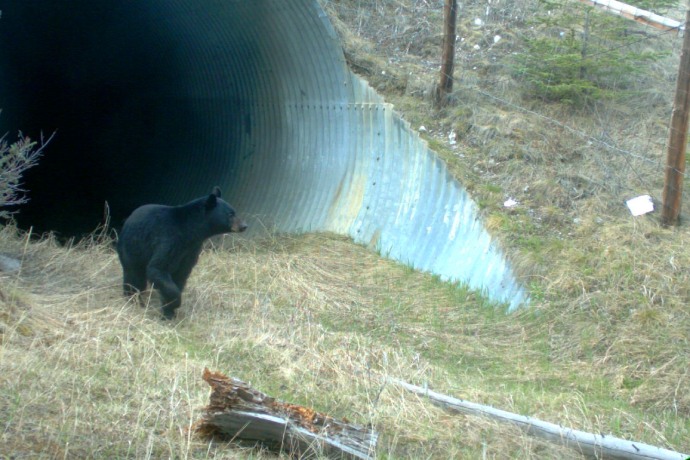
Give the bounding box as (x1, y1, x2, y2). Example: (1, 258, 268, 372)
(388, 378, 690, 460)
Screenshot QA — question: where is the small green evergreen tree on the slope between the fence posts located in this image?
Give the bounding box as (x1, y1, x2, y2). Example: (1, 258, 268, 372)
(515, 0, 668, 107)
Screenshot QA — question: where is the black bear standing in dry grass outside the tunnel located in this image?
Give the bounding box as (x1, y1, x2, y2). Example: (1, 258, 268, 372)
(117, 187, 247, 319)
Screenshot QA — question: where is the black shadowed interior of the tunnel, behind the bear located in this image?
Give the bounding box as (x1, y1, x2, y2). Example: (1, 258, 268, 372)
(0, 0, 245, 237)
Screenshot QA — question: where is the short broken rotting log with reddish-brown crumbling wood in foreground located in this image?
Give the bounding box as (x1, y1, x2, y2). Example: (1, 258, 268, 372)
(195, 369, 378, 459)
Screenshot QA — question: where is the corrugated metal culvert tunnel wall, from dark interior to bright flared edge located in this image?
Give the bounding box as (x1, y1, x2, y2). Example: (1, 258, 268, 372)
(0, 0, 525, 308)
